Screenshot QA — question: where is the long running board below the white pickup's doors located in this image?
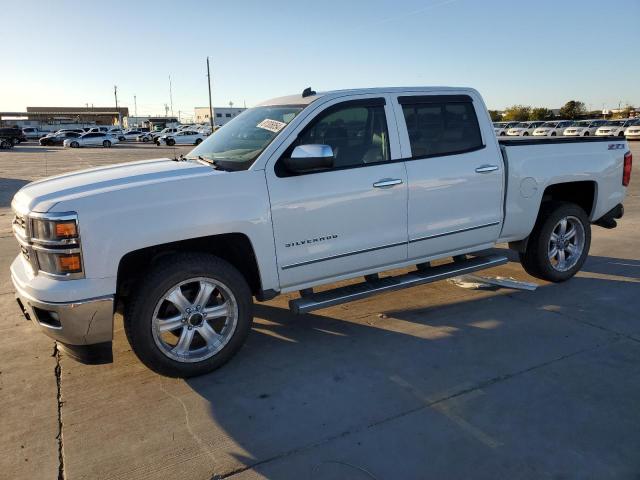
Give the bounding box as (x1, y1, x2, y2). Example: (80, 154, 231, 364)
(289, 255, 509, 314)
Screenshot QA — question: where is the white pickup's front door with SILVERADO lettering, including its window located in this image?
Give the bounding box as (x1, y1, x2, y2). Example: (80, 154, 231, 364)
(266, 96, 407, 290)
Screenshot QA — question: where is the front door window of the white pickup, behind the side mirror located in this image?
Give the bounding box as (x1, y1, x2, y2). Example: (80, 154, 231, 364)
(289, 102, 390, 168)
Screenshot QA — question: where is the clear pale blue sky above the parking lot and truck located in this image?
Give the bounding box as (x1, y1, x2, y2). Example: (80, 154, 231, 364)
(0, 0, 640, 116)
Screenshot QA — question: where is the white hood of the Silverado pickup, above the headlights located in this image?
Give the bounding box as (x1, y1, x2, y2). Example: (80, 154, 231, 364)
(11, 158, 220, 213)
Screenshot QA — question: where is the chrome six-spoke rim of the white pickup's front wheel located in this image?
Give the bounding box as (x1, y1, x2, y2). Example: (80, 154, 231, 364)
(151, 277, 238, 362)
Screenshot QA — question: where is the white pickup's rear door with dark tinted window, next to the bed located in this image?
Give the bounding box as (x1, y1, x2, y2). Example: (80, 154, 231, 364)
(395, 91, 504, 259)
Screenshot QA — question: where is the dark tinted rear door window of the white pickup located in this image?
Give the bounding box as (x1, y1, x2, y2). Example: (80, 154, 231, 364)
(398, 95, 483, 158)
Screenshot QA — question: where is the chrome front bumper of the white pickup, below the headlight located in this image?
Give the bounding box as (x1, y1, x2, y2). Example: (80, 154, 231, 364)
(11, 275, 114, 345)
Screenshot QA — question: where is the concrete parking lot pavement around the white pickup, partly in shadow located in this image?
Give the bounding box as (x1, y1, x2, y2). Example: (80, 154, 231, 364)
(0, 143, 640, 480)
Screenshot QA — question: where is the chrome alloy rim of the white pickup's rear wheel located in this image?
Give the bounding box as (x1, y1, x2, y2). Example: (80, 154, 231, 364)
(547, 216, 585, 272)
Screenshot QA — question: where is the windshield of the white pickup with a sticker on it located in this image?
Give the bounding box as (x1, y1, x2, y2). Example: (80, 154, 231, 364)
(187, 105, 304, 170)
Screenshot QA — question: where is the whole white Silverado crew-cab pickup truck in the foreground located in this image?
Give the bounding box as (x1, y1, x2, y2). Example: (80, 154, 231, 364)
(11, 87, 631, 377)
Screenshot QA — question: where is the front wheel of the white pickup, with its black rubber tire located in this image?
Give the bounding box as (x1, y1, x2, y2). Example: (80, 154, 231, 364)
(124, 253, 253, 378)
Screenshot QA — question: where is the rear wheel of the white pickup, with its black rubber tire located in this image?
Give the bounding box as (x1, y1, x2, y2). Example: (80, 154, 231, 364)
(520, 202, 591, 283)
